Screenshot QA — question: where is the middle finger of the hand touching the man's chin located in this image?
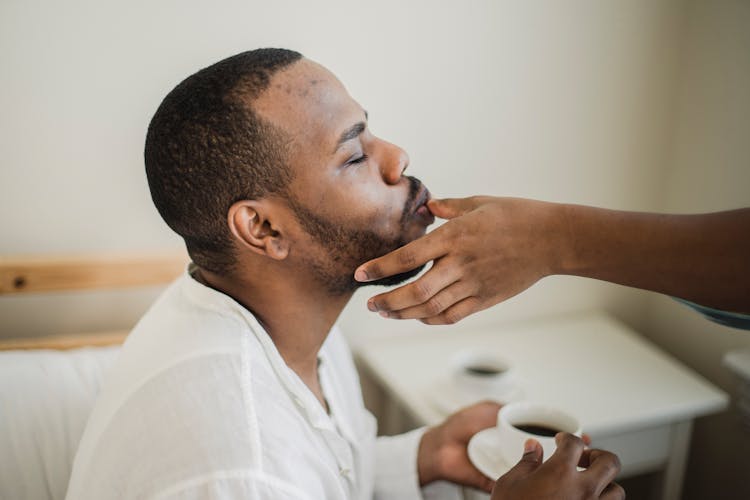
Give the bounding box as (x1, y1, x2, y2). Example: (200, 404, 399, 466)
(367, 259, 459, 317)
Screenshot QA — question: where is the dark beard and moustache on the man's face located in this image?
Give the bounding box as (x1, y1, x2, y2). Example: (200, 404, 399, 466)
(288, 176, 425, 296)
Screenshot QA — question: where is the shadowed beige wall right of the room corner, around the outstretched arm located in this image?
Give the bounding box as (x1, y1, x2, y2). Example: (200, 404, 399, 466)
(643, 0, 750, 499)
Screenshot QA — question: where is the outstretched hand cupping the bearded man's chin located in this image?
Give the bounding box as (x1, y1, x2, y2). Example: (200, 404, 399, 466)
(354, 196, 565, 325)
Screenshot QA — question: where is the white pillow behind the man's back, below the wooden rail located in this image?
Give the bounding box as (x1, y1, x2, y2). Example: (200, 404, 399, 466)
(0, 346, 120, 500)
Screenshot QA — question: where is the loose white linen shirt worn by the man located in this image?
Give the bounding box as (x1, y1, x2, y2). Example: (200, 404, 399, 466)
(66, 273, 434, 500)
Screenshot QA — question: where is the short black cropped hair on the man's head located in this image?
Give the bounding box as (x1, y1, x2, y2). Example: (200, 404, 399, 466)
(144, 49, 302, 274)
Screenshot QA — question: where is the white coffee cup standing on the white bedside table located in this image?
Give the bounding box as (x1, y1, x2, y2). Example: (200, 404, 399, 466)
(452, 350, 515, 399)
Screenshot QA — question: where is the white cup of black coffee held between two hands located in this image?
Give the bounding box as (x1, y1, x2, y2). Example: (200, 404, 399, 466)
(497, 401, 581, 464)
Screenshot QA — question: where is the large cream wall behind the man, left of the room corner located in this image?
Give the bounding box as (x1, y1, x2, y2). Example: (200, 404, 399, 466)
(0, 0, 682, 336)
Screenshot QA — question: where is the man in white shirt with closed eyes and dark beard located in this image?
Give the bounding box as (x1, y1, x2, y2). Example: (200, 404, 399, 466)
(68, 49, 618, 499)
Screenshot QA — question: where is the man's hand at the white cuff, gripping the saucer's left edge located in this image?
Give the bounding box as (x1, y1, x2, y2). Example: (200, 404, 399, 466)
(417, 401, 500, 492)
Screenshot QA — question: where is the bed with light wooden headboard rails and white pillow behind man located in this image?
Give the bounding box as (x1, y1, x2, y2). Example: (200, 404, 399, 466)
(0, 252, 187, 500)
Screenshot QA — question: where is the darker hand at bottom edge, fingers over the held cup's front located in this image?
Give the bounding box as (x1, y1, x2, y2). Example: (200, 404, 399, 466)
(492, 433, 625, 500)
